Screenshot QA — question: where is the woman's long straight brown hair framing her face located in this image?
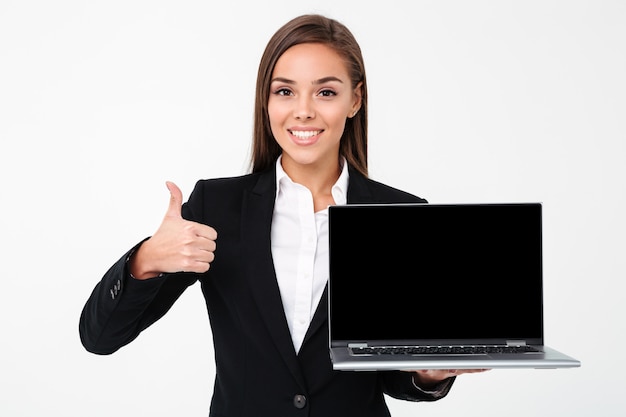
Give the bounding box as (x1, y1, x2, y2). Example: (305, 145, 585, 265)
(250, 14, 368, 176)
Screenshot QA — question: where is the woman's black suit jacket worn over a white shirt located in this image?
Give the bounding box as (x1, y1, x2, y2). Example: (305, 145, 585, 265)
(79, 167, 452, 417)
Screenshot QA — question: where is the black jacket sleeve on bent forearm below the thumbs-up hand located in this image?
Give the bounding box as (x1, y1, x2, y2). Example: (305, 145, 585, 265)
(78, 243, 197, 355)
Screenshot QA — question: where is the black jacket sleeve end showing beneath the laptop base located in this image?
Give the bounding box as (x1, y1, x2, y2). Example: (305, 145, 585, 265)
(382, 371, 456, 401)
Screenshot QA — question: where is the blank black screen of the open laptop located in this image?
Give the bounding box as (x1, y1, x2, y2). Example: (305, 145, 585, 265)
(329, 203, 543, 340)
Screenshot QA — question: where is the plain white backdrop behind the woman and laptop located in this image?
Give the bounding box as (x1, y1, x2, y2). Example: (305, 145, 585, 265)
(0, 0, 626, 417)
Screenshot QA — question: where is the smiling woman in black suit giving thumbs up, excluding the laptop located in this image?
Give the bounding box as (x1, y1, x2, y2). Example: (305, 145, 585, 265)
(80, 15, 482, 417)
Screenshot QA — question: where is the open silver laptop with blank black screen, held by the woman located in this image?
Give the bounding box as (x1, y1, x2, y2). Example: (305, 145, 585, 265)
(328, 203, 580, 371)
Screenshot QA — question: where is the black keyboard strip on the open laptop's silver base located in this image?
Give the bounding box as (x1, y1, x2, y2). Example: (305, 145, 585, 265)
(350, 345, 541, 355)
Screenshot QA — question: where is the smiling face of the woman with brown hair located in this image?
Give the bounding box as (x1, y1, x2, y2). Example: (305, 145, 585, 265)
(268, 43, 361, 173)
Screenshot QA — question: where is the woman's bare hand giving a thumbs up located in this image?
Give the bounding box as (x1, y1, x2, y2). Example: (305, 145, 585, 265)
(129, 181, 217, 279)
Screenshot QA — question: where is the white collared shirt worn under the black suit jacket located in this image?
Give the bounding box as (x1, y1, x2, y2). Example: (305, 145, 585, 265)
(271, 156, 348, 353)
